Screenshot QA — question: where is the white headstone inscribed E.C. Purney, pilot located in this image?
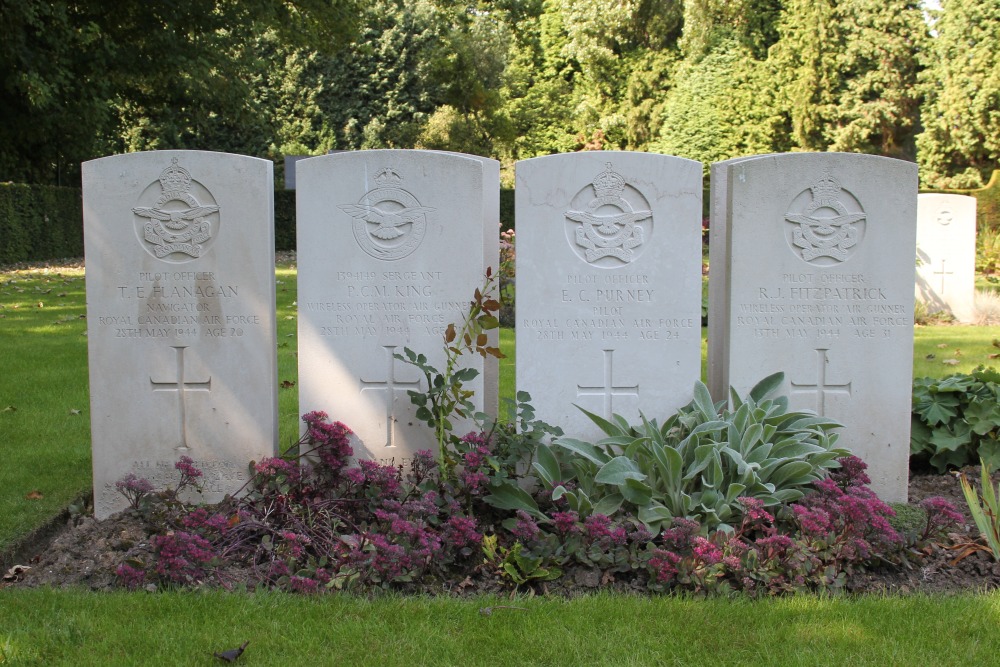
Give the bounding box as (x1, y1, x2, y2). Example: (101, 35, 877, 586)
(515, 151, 701, 438)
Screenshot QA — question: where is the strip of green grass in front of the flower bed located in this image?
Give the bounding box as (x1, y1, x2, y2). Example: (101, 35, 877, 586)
(0, 590, 1000, 667)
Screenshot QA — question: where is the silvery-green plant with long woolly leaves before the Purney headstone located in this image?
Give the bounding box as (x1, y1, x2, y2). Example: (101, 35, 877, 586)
(534, 373, 847, 534)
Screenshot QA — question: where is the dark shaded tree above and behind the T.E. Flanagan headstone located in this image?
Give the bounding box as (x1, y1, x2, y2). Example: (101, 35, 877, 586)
(0, 0, 363, 182)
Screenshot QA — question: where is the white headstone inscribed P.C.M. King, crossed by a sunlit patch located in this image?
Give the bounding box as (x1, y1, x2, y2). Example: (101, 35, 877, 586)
(297, 150, 499, 464)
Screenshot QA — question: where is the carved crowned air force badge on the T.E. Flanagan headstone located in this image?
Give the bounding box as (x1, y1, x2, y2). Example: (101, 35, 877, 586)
(132, 158, 219, 259)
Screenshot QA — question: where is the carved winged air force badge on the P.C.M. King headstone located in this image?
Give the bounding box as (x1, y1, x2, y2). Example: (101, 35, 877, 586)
(340, 167, 435, 260)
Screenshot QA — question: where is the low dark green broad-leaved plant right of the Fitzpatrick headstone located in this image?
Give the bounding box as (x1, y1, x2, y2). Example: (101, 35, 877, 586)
(910, 366, 1000, 472)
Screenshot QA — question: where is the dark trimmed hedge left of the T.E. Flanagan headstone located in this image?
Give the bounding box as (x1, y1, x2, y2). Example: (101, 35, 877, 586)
(0, 183, 83, 264)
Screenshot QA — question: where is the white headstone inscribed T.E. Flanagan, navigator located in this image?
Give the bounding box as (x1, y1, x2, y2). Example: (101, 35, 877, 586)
(83, 151, 277, 518)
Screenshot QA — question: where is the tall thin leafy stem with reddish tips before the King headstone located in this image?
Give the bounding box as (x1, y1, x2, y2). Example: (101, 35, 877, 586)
(394, 268, 504, 470)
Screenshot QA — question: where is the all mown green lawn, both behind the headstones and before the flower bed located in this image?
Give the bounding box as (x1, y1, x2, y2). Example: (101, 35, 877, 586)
(0, 258, 1000, 666)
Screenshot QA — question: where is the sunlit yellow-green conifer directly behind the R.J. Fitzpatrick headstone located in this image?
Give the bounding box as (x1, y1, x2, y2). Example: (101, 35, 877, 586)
(768, 0, 927, 159)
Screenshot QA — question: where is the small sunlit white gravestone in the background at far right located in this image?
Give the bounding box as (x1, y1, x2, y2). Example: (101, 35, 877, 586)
(917, 193, 976, 322)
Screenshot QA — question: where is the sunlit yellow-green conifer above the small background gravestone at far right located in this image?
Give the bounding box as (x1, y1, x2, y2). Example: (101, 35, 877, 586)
(917, 0, 1000, 188)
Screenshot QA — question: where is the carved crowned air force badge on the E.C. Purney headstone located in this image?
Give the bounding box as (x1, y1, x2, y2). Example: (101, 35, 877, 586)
(565, 162, 653, 264)
